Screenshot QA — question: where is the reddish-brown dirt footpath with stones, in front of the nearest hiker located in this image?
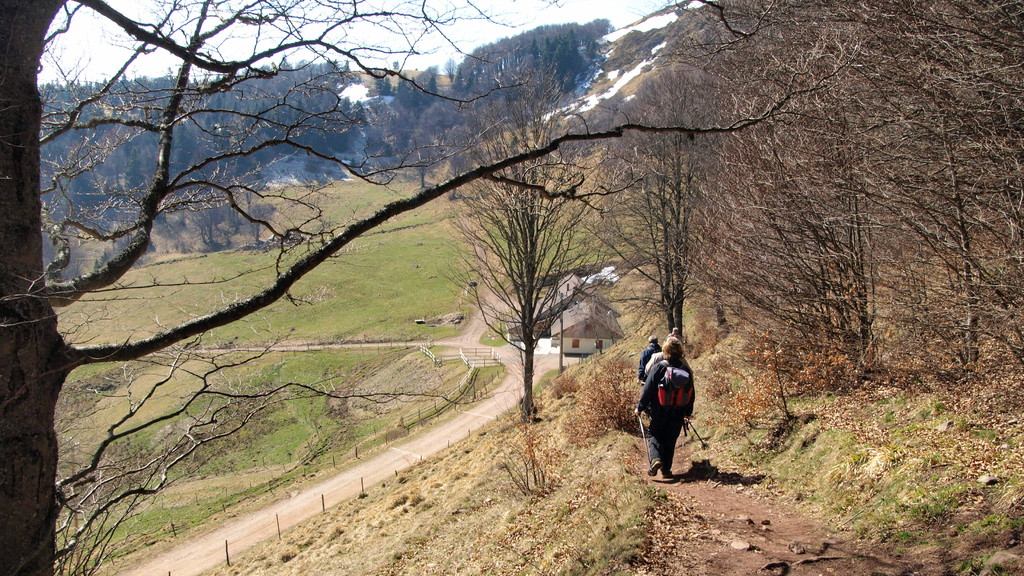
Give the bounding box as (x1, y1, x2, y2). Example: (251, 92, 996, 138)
(635, 444, 943, 576)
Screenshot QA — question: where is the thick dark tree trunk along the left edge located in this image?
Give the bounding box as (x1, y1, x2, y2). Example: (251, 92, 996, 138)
(0, 0, 70, 576)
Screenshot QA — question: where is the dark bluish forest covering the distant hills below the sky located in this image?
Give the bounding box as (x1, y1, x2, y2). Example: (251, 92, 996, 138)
(41, 20, 610, 273)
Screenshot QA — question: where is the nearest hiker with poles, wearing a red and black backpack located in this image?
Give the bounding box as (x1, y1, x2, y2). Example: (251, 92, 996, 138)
(636, 338, 694, 478)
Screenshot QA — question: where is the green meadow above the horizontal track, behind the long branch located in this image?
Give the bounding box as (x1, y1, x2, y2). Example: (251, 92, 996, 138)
(60, 181, 466, 344)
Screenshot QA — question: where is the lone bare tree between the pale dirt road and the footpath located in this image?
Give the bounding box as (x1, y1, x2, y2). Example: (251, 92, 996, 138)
(460, 77, 599, 422)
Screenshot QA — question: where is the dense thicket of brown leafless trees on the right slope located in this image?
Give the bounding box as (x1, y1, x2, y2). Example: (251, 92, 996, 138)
(718, 0, 1024, 378)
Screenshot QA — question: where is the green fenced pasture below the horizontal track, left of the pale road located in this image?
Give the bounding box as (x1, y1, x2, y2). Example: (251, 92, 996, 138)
(66, 348, 501, 556)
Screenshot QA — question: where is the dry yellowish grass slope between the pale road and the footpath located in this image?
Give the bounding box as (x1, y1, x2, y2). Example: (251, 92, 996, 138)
(202, 366, 654, 576)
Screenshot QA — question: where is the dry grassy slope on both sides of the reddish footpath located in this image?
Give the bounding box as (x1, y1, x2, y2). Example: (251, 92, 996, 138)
(172, 309, 1024, 575)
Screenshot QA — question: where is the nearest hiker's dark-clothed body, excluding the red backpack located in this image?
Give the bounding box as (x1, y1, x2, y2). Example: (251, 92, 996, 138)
(636, 338, 693, 478)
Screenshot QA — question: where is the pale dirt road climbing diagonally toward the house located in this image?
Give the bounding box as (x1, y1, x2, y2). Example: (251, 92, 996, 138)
(118, 315, 558, 576)
